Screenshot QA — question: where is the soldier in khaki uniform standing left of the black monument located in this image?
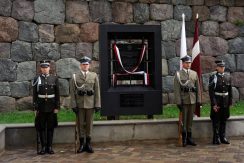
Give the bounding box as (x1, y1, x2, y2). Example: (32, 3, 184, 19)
(70, 56, 101, 153)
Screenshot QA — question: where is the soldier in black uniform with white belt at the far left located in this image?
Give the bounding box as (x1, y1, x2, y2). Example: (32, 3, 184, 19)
(33, 60, 60, 155)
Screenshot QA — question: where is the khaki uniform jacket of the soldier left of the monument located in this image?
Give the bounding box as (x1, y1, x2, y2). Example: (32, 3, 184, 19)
(70, 71, 101, 109)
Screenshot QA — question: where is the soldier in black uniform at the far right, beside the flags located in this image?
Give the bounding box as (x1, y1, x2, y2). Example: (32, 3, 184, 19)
(209, 60, 232, 145)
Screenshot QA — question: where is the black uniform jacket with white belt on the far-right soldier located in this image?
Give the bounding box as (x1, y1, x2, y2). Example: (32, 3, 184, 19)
(209, 72, 232, 108)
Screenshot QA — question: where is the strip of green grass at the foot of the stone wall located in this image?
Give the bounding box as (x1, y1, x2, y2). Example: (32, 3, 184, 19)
(0, 101, 244, 124)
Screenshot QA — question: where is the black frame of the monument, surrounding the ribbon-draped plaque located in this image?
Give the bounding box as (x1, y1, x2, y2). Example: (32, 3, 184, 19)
(99, 24, 162, 116)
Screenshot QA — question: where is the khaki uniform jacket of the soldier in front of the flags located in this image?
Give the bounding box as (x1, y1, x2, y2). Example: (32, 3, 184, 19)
(174, 70, 201, 105)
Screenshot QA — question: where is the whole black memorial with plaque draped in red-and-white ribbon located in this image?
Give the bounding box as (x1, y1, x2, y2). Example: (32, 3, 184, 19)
(99, 24, 162, 116)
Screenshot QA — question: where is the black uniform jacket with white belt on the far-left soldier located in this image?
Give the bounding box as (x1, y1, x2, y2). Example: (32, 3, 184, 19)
(33, 75, 60, 112)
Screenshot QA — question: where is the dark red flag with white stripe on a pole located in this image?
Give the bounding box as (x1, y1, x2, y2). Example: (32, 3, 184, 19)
(191, 14, 202, 117)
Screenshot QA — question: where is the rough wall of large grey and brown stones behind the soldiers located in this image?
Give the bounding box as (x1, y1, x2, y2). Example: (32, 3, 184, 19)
(0, 0, 244, 112)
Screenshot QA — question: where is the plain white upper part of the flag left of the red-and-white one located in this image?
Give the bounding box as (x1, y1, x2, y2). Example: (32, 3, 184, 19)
(180, 14, 187, 69)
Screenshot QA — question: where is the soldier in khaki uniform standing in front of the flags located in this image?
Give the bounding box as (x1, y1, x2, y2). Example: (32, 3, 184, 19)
(174, 55, 201, 147)
